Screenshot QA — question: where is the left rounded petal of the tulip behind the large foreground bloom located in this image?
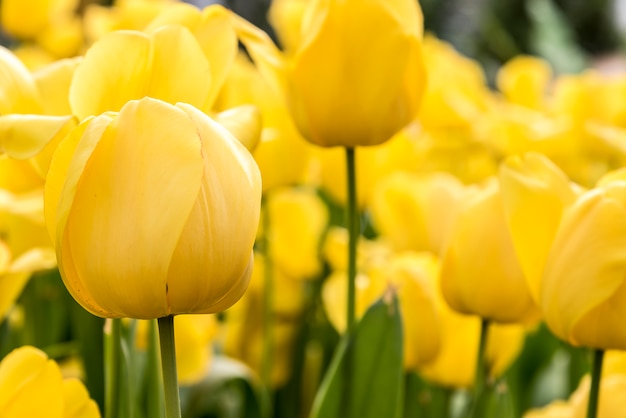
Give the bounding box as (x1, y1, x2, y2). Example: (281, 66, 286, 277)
(69, 31, 151, 120)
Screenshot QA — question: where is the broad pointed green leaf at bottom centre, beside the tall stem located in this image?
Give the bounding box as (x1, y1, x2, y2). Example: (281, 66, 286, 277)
(311, 294, 403, 418)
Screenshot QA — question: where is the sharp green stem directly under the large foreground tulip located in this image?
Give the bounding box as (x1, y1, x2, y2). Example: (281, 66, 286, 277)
(158, 315, 181, 418)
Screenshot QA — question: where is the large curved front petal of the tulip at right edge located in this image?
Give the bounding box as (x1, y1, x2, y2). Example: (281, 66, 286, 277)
(540, 187, 626, 348)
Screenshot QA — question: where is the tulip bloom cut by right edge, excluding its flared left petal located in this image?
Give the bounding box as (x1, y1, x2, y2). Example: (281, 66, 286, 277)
(540, 170, 626, 350)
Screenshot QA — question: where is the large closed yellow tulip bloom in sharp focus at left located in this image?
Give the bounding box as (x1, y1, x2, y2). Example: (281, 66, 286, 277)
(45, 98, 261, 319)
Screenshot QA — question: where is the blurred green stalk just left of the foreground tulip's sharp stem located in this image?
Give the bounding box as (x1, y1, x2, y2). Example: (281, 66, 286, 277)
(104, 319, 122, 418)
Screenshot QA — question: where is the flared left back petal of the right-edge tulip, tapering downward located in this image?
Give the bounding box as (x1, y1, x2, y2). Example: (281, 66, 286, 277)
(499, 153, 576, 304)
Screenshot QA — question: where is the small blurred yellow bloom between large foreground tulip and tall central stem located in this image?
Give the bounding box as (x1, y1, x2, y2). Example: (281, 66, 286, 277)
(266, 188, 329, 279)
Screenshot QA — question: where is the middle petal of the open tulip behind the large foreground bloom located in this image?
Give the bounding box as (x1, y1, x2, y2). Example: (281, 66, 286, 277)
(147, 25, 213, 110)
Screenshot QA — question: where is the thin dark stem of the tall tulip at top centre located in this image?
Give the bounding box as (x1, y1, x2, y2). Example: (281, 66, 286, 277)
(346, 147, 360, 335)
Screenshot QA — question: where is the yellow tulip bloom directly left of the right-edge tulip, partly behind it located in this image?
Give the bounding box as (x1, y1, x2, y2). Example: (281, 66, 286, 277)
(441, 182, 538, 323)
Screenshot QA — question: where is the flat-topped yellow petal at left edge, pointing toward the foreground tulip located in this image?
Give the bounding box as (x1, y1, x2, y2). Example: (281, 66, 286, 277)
(0, 114, 73, 159)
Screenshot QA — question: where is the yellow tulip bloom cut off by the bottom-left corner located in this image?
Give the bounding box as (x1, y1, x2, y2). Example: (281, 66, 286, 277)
(0, 346, 100, 418)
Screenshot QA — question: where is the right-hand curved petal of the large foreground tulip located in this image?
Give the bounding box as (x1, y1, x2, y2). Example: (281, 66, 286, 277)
(167, 104, 261, 313)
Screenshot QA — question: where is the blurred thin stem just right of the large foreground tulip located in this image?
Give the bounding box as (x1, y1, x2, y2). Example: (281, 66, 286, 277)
(261, 201, 274, 414)
